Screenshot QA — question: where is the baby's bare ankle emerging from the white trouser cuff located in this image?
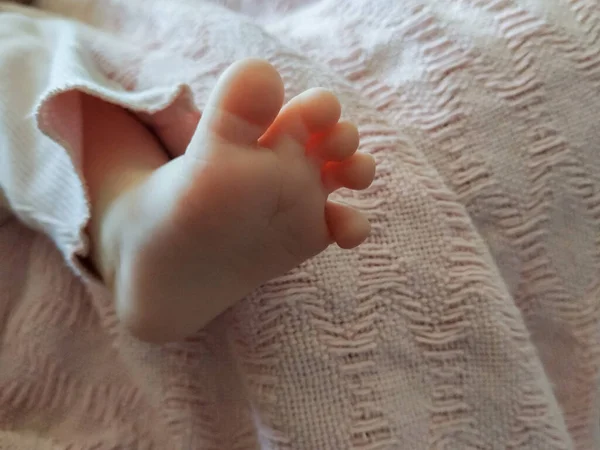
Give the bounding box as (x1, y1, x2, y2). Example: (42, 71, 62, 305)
(81, 94, 168, 287)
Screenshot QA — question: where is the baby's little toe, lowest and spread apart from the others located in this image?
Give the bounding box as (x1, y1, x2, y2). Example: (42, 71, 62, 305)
(325, 201, 371, 249)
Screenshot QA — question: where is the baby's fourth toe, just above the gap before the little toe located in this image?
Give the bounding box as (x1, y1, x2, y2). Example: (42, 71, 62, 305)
(323, 153, 376, 193)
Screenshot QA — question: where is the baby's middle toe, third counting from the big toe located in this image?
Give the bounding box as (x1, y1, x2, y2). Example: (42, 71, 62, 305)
(308, 122, 359, 162)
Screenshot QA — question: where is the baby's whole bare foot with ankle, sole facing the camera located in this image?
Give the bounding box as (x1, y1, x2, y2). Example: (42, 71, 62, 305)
(83, 59, 375, 342)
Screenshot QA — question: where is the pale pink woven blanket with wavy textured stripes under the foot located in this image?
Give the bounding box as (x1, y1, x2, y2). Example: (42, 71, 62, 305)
(0, 0, 600, 450)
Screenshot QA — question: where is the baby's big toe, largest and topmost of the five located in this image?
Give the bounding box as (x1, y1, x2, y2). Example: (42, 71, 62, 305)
(188, 59, 284, 153)
